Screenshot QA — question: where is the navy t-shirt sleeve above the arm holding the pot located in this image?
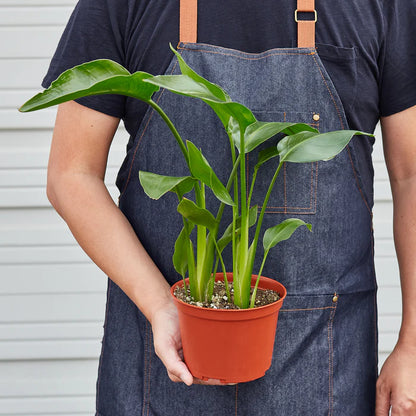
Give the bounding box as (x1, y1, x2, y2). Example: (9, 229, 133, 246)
(42, 0, 125, 118)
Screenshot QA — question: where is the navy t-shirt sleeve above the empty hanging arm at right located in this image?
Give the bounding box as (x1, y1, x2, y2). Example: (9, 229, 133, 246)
(380, 0, 416, 116)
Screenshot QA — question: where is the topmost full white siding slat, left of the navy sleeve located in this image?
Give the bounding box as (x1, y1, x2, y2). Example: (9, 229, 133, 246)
(0, 6, 72, 26)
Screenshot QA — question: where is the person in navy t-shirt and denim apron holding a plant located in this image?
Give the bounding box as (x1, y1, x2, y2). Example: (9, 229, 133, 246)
(43, 0, 416, 416)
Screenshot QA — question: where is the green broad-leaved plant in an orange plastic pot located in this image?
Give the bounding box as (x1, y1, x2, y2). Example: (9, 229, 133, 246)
(20, 47, 365, 383)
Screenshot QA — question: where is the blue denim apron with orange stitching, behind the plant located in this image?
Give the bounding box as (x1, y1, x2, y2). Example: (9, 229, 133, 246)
(96, 1, 377, 416)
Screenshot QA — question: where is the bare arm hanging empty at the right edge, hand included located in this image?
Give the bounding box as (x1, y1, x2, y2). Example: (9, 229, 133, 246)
(376, 106, 416, 416)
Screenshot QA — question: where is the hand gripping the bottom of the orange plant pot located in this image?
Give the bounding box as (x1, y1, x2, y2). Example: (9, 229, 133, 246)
(152, 303, 234, 386)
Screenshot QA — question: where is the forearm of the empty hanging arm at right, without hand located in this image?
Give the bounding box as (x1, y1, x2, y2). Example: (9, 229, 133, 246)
(392, 177, 416, 344)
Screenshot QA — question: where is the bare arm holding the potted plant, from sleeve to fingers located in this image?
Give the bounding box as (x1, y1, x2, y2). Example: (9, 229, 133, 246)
(47, 102, 193, 385)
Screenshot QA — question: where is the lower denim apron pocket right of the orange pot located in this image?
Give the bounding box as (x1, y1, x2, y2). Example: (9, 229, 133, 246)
(240, 295, 337, 415)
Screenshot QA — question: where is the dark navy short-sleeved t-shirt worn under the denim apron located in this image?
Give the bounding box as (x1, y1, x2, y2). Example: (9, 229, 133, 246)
(42, 0, 416, 136)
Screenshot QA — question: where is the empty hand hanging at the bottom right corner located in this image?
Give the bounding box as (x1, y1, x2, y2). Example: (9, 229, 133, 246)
(376, 341, 416, 416)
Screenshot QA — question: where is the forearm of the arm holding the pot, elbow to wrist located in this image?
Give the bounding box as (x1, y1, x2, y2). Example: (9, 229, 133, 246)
(48, 172, 171, 322)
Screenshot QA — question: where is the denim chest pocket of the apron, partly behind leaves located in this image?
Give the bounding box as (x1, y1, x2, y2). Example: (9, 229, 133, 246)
(247, 110, 319, 214)
